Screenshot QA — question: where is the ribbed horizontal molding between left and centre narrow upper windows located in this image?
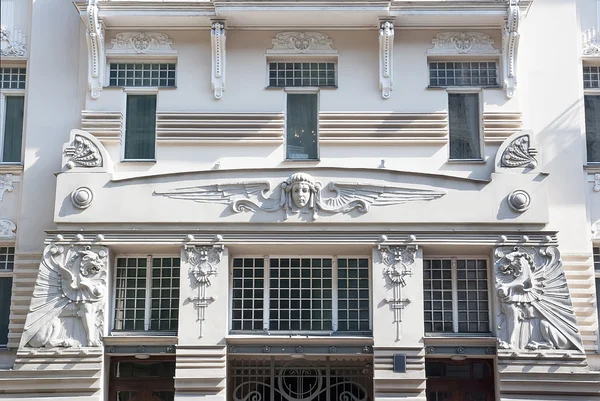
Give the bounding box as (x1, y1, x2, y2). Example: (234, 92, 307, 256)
(156, 112, 284, 144)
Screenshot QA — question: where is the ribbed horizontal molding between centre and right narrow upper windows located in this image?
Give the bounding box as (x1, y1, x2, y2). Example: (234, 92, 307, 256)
(319, 112, 448, 145)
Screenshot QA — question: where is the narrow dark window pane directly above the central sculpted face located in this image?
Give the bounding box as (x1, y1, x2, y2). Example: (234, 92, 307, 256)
(286, 93, 319, 159)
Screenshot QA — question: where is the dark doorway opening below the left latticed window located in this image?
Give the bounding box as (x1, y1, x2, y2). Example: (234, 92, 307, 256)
(108, 356, 175, 401)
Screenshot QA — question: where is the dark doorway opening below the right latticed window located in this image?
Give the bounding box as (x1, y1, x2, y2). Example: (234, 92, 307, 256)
(425, 359, 495, 401)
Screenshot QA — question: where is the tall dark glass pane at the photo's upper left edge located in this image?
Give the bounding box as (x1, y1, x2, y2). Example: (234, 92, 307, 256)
(2, 96, 25, 163)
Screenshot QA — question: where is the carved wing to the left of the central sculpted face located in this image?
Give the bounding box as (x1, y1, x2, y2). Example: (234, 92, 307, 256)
(154, 181, 270, 204)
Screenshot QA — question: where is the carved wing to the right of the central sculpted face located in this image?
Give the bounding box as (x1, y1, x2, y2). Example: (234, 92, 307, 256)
(324, 182, 446, 212)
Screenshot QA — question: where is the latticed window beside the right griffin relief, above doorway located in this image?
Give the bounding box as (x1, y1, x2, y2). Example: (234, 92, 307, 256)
(423, 258, 490, 333)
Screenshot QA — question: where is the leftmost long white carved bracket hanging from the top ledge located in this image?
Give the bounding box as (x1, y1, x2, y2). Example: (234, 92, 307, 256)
(85, 0, 106, 99)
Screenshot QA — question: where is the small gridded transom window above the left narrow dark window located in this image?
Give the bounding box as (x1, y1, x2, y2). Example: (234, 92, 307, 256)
(109, 63, 175, 88)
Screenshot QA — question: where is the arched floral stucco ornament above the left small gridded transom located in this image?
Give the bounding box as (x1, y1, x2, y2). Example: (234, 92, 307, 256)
(106, 32, 177, 56)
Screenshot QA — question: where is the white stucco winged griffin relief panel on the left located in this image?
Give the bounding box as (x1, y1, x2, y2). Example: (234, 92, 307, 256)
(21, 244, 108, 348)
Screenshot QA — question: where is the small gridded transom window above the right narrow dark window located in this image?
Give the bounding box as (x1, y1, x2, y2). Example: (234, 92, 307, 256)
(429, 61, 498, 87)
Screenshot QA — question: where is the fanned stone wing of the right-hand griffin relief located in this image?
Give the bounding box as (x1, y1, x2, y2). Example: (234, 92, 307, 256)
(532, 247, 583, 352)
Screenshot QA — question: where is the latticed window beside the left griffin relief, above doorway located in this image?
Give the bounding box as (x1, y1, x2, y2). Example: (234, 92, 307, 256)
(114, 257, 180, 331)
